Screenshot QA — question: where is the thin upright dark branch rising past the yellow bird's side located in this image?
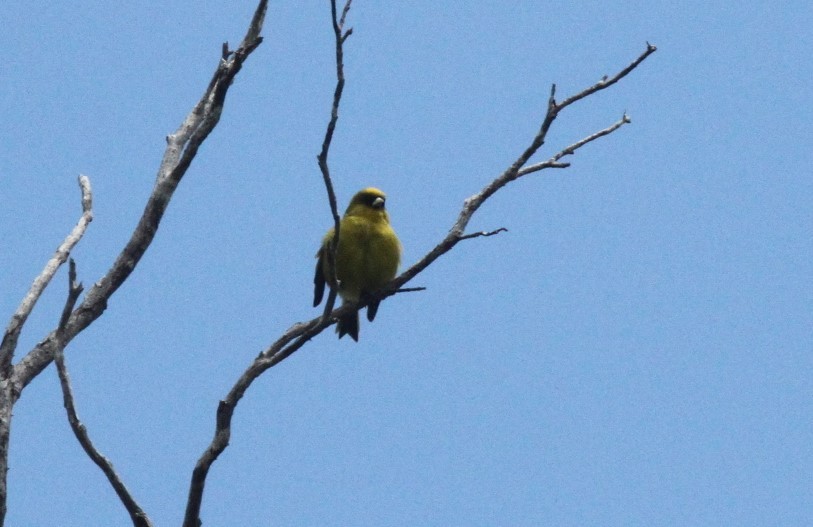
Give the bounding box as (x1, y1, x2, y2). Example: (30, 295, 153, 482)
(317, 0, 353, 317)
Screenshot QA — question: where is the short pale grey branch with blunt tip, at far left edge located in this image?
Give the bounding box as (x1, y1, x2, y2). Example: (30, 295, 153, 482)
(0, 175, 93, 379)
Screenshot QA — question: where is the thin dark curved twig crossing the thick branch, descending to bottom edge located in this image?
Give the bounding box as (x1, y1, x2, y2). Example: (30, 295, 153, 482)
(54, 258, 152, 527)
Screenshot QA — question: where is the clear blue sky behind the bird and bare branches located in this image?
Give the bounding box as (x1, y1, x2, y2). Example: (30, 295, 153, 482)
(0, 0, 813, 527)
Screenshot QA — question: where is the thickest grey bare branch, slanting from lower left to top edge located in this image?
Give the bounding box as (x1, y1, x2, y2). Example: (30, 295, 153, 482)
(12, 0, 268, 393)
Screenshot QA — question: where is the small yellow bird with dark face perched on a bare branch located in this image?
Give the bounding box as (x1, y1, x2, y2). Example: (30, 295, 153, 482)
(313, 187, 401, 342)
